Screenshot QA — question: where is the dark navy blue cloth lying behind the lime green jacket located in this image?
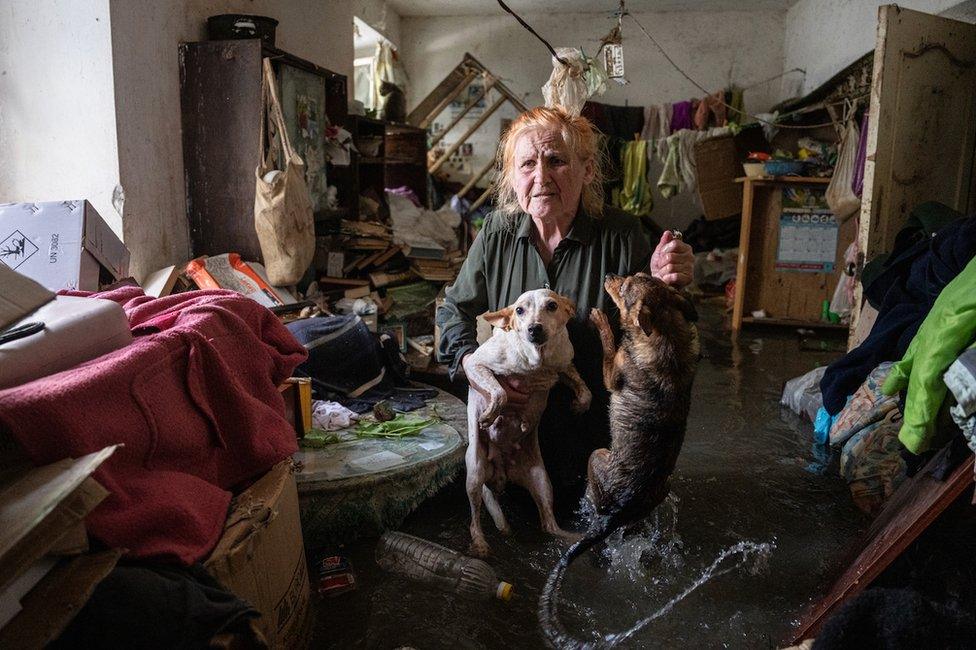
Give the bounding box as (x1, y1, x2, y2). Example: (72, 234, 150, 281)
(820, 217, 976, 415)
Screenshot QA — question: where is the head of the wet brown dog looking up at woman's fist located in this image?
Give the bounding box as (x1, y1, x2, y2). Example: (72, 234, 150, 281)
(603, 273, 698, 335)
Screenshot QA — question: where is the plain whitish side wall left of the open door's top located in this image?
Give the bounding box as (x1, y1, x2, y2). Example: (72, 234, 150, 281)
(783, 0, 967, 97)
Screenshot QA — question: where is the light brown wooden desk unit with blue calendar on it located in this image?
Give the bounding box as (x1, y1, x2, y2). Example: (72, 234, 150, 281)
(732, 176, 855, 336)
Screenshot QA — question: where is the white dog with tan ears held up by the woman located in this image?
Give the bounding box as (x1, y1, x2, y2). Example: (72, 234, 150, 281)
(465, 289, 592, 557)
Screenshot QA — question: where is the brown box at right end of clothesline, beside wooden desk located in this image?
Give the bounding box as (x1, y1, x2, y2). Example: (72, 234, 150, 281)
(695, 135, 742, 219)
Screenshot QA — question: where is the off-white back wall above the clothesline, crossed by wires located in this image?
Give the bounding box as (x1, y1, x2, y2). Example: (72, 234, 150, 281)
(401, 11, 785, 228)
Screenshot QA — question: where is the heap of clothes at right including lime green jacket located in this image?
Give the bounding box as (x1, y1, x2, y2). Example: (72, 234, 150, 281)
(796, 208, 976, 512)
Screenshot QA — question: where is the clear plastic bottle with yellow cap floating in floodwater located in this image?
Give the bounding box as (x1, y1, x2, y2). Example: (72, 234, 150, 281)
(376, 532, 513, 602)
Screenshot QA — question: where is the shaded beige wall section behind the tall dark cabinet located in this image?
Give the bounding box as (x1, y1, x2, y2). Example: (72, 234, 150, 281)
(112, 0, 352, 278)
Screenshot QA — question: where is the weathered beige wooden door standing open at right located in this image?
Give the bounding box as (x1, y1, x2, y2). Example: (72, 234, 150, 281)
(851, 5, 976, 332)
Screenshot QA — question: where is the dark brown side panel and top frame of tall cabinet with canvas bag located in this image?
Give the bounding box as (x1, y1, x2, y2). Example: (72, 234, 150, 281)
(180, 39, 347, 261)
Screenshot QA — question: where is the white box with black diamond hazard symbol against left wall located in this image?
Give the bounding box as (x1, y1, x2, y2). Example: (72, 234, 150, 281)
(0, 200, 129, 291)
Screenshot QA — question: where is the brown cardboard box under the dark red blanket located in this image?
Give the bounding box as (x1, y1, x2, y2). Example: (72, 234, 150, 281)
(204, 460, 311, 648)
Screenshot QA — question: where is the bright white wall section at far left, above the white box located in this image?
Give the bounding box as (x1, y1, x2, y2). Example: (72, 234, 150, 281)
(0, 0, 122, 235)
